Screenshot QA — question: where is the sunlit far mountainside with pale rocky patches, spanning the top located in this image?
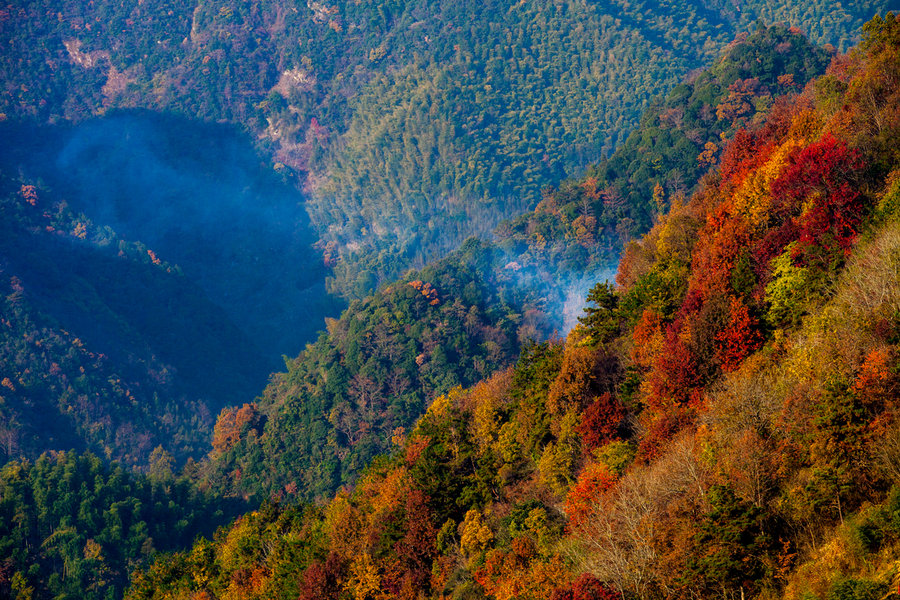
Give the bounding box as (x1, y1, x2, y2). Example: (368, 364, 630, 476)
(0, 0, 890, 297)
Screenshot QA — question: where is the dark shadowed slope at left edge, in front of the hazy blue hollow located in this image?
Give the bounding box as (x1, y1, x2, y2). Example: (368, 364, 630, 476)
(0, 175, 265, 466)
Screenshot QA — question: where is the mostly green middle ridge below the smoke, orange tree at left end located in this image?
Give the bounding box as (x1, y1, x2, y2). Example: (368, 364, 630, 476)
(200, 240, 550, 499)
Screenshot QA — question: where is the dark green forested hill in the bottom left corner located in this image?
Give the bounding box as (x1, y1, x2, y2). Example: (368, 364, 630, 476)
(0, 450, 247, 599)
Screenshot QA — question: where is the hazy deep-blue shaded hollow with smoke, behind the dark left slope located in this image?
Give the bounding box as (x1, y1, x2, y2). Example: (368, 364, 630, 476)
(0, 110, 343, 366)
